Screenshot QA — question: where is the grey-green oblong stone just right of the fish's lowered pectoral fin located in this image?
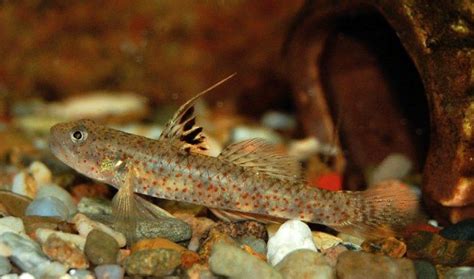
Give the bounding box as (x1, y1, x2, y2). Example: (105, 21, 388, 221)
(137, 218, 192, 242)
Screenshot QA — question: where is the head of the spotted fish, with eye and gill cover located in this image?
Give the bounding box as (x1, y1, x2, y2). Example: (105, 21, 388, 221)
(49, 119, 122, 186)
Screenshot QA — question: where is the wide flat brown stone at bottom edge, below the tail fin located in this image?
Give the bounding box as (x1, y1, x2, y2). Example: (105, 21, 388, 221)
(336, 251, 416, 279)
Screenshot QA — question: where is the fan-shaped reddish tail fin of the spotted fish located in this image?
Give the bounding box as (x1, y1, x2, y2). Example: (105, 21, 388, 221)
(336, 181, 426, 238)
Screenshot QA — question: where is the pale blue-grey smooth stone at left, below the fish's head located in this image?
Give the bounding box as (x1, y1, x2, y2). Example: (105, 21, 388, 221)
(25, 197, 69, 221)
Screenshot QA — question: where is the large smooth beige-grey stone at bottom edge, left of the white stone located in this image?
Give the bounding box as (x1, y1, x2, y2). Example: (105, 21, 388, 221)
(209, 243, 283, 279)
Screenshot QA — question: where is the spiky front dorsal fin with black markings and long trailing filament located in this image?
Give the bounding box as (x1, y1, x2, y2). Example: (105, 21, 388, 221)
(160, 73, 235, 152)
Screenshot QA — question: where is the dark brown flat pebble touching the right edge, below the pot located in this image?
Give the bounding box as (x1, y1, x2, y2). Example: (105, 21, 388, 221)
(407, 231, 474, 266)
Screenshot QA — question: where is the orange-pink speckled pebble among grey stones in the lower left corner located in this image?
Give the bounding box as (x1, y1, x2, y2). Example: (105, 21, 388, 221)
(42, 234, 89, 268)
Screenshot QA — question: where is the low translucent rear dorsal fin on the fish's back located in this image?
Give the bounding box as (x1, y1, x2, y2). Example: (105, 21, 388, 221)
(219, 139, 302, 182)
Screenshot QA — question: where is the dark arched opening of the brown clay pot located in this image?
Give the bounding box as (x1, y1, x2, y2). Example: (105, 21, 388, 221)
(315, 10, 429, 189)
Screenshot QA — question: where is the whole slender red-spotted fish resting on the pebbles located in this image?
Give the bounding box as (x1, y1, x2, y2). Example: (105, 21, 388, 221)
(49, 76, 423, 237)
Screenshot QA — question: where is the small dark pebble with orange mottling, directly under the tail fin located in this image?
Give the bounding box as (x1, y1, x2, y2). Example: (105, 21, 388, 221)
(361, 237, 407, 258)
